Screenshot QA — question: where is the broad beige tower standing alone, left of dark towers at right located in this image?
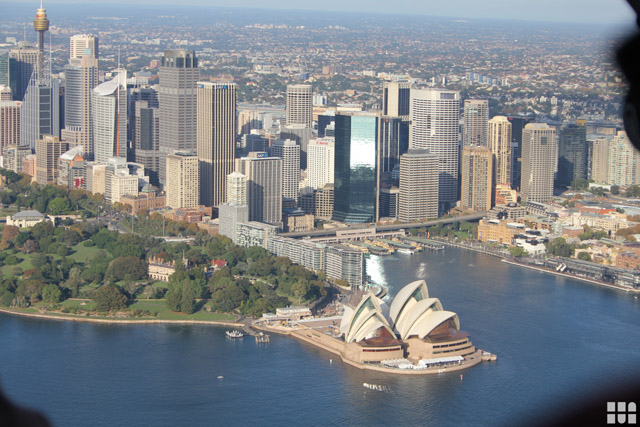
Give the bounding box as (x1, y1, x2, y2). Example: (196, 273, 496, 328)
(520, 123, 558, 202)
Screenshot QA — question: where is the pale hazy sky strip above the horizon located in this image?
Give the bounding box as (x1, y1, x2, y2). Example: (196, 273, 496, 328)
(46, 0, 635, 25)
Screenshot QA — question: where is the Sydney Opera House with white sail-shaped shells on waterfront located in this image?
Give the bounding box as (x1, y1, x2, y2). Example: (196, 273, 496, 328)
(296, 280, 495, 374)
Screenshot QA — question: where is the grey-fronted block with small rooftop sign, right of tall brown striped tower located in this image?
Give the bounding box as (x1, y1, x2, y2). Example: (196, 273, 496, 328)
(236, 152, 282, 226)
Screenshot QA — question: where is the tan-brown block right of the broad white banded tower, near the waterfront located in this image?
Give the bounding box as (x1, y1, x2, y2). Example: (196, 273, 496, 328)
(460, 145, 494, 212)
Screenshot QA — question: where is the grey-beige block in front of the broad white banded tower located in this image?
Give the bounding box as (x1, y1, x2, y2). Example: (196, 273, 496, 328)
(398, 148, 438, 222)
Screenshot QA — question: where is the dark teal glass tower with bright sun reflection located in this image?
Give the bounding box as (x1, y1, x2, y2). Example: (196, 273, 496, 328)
(333, 113, 379, 223)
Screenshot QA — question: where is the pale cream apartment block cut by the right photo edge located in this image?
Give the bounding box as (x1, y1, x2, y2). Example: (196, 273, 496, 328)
(607, 131, 640, 185)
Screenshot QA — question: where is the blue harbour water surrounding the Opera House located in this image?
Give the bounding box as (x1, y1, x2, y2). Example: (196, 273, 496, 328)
(0, 248, 640, 426)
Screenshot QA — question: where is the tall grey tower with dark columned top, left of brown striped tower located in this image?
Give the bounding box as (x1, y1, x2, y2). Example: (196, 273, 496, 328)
(158, 49, 200, 185)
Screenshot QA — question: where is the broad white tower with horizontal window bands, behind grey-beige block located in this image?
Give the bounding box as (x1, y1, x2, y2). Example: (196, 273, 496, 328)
(409, 89, 460, 213)
